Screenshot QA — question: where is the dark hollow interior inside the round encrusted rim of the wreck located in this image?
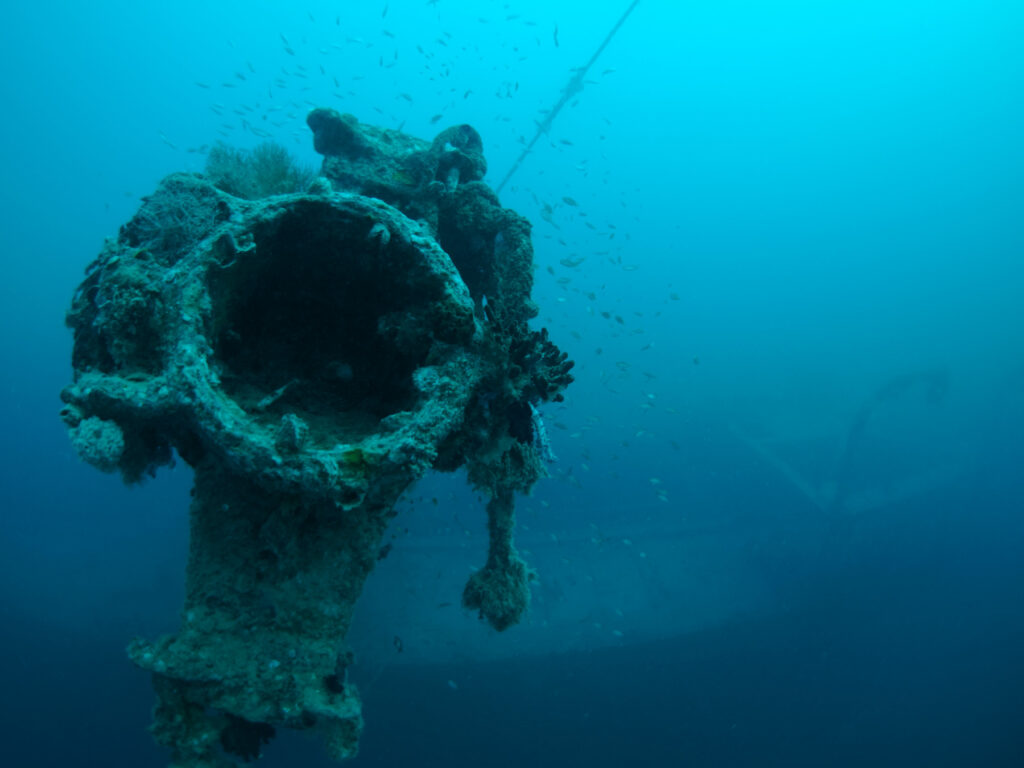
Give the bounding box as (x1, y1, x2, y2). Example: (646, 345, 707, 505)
(211, 206, 431, 441)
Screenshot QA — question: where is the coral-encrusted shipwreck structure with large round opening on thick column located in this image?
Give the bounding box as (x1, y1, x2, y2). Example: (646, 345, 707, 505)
(61, 109, 572, 768)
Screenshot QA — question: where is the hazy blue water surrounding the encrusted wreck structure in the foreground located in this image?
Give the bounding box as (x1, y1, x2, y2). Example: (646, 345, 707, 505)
(0, 0, 1024, 768)
